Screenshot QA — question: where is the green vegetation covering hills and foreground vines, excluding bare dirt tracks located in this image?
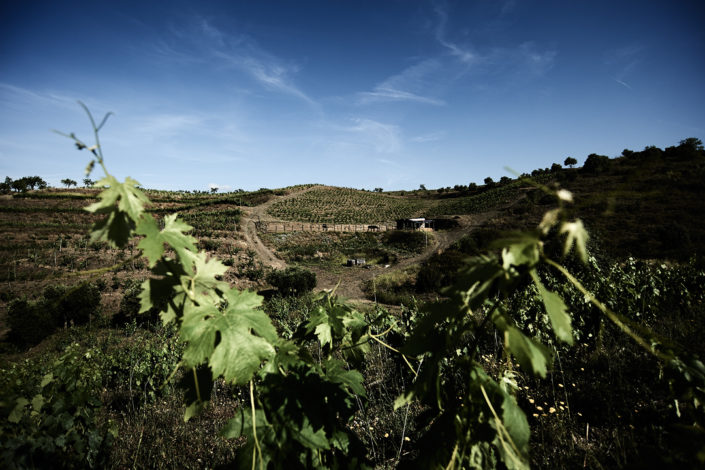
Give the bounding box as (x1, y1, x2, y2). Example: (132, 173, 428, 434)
(0, 132, 705, 469)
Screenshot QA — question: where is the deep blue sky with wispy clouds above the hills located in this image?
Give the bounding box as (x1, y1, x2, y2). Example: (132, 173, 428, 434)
(0, 0, 705, 190)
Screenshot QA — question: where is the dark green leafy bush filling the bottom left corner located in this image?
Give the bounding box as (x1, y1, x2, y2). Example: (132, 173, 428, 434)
(0, 344, 116, 468)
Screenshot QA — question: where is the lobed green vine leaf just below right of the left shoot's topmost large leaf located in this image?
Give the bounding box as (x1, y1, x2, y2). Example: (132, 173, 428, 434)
(135, 214, 197, 268)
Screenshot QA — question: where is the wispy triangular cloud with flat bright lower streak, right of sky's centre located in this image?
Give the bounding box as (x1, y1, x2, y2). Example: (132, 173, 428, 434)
(357, 59, 445, 106)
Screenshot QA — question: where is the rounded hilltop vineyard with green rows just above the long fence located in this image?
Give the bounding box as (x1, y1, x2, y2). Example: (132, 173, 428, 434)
(267, 187, 426, 224)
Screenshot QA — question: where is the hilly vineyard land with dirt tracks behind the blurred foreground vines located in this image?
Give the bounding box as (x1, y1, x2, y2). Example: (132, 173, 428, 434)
(0, 140, 705, 468)
